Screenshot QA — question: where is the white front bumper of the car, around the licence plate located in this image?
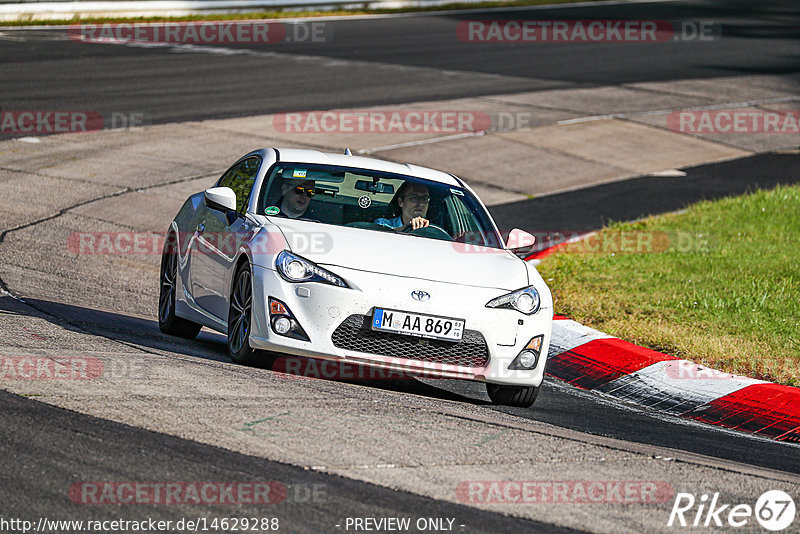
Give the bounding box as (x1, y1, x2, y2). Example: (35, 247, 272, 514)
(250, 266, 553, 386)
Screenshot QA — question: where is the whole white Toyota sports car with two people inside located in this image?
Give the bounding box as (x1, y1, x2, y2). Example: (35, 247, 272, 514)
(158, 148, 553, 407)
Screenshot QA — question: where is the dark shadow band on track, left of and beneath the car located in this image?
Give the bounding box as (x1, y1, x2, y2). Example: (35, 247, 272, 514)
(0, 297, 490, 405)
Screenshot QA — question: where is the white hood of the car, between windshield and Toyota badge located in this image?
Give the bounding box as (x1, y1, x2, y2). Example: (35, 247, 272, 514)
(270, 218, 528, 291)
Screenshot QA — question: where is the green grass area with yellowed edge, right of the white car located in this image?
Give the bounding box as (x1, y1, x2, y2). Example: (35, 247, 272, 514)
(539, 186, 800, 386)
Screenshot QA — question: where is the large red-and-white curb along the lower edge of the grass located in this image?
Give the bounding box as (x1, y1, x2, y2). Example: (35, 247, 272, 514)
(547, 316, 800, 443)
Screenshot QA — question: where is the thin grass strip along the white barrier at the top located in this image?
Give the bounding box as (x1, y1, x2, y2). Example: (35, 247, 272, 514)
(0, 0, 601, 27)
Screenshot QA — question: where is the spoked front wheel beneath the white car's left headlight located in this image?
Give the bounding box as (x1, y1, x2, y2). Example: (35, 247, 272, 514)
(228, 263, 258, 365)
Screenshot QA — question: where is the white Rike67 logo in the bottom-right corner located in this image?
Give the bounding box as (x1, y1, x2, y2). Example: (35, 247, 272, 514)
(667, 490, 795, 532)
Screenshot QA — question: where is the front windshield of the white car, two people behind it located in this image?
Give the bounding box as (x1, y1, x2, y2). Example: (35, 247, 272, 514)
(258, 163, 502, 248)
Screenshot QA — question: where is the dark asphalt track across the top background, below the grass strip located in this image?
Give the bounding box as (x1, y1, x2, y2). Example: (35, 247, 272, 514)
(0, 1, 800, 123)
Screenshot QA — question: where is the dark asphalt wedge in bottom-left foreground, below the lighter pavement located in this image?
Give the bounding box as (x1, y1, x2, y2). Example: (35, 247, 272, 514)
(0, 392, 572, 533)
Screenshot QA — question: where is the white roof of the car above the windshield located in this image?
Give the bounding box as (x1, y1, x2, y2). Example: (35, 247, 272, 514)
(275, 148, 463, 187)
